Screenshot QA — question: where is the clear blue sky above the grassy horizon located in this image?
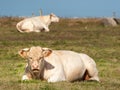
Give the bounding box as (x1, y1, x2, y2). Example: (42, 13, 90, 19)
(0, 0, 120, 17)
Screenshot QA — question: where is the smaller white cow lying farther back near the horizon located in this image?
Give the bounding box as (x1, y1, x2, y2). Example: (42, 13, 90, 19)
(16, 14, 59, 33)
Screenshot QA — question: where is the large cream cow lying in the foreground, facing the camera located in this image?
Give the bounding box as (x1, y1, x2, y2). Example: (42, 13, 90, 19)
(19, 46, 99, 82)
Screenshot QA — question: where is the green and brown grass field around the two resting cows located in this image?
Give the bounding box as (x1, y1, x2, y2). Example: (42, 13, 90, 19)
(0, 17, 120, 90)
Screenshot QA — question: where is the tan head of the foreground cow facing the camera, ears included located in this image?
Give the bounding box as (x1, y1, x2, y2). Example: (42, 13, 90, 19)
(19, 46, 52, 72)
